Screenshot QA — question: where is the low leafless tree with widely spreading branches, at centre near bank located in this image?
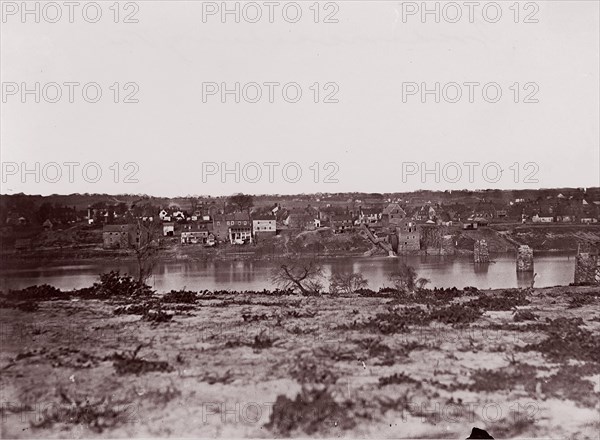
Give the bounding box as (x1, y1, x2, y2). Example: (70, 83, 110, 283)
(271, 260, 323, 295)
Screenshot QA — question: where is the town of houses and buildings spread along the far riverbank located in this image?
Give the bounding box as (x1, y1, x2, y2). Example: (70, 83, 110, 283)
(96, 194, 600, 251)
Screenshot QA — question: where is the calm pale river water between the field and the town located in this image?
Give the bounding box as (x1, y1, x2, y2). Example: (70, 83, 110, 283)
(0, 253, 575, 292)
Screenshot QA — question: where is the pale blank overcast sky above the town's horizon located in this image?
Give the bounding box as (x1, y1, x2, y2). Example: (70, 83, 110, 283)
(1, 0, 600, 196)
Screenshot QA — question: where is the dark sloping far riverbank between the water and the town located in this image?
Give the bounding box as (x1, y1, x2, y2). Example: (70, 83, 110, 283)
(0, 224, 600, 268)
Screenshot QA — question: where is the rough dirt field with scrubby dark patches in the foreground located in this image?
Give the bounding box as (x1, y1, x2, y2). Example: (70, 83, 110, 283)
(0, 287, 600, 439)
